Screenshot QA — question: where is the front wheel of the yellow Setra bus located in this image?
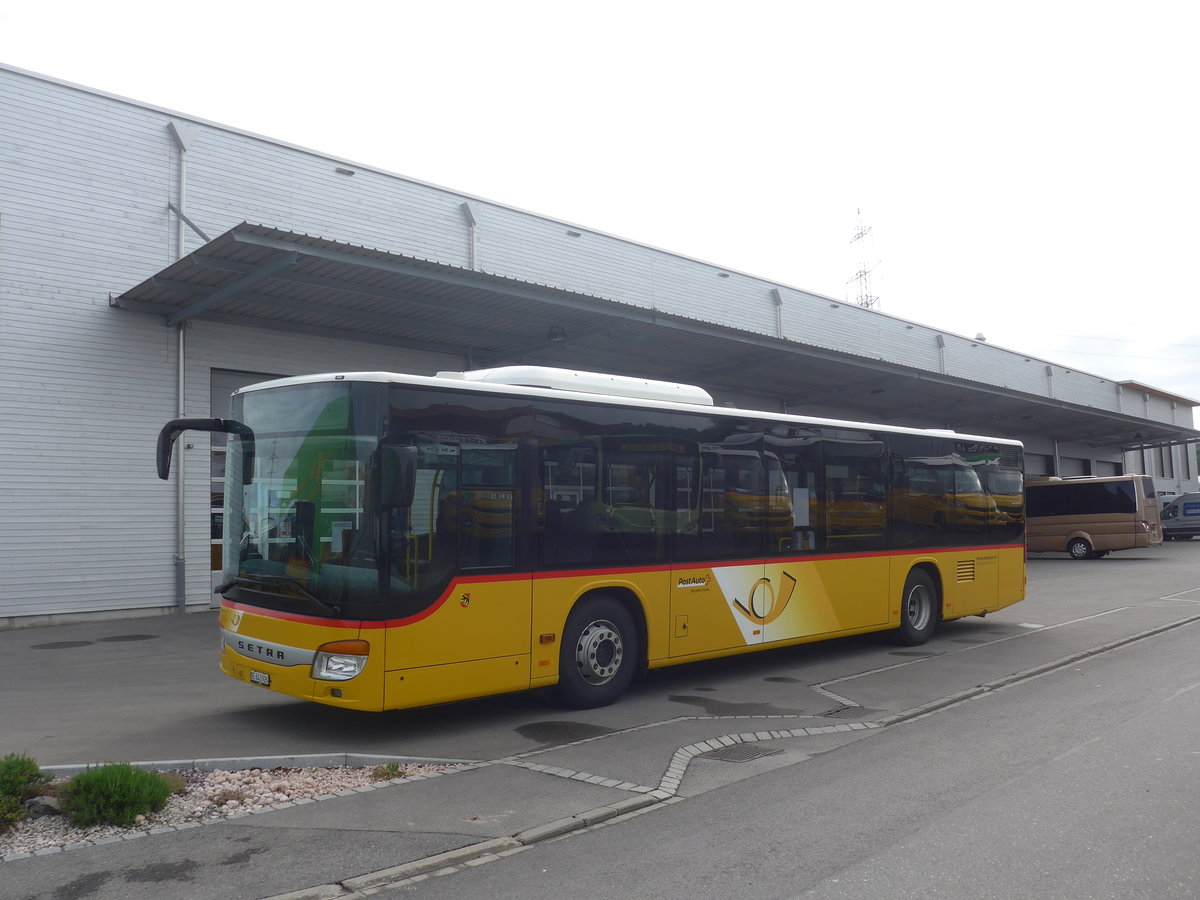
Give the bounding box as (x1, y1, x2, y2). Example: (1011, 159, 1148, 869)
(554, 594, 638, 709)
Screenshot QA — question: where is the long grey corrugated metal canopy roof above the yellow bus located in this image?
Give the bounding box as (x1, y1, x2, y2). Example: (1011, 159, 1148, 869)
(110, 223, 1200, 449)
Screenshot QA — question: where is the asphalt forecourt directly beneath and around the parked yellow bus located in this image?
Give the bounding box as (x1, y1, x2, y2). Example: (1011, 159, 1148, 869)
(9, 541, 1200, 766)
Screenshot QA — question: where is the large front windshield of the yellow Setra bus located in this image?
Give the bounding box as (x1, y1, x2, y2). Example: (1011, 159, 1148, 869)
(220, 382, 384, 617)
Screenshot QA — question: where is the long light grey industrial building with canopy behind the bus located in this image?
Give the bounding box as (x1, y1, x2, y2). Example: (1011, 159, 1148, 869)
(0, 66, 1200, 626)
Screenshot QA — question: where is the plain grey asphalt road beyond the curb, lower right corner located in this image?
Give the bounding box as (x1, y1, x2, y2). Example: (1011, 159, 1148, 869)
(380, 607, 1200, 900)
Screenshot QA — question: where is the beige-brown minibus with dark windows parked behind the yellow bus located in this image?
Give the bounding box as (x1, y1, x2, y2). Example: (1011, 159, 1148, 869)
(1025, 475, 1163, 559)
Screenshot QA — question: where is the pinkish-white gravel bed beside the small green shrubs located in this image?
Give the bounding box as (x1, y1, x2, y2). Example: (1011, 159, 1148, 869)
(0, 763, 457, 860)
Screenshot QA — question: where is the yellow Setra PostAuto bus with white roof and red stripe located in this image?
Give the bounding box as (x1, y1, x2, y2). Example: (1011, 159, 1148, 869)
(158, 367, 1025, 710)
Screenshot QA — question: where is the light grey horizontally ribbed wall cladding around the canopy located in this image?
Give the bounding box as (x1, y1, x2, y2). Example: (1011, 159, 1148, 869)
(0, 66, 1190, 625)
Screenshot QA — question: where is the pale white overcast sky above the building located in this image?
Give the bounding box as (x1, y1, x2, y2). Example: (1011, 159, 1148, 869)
(7, 0, 1200, 415)
